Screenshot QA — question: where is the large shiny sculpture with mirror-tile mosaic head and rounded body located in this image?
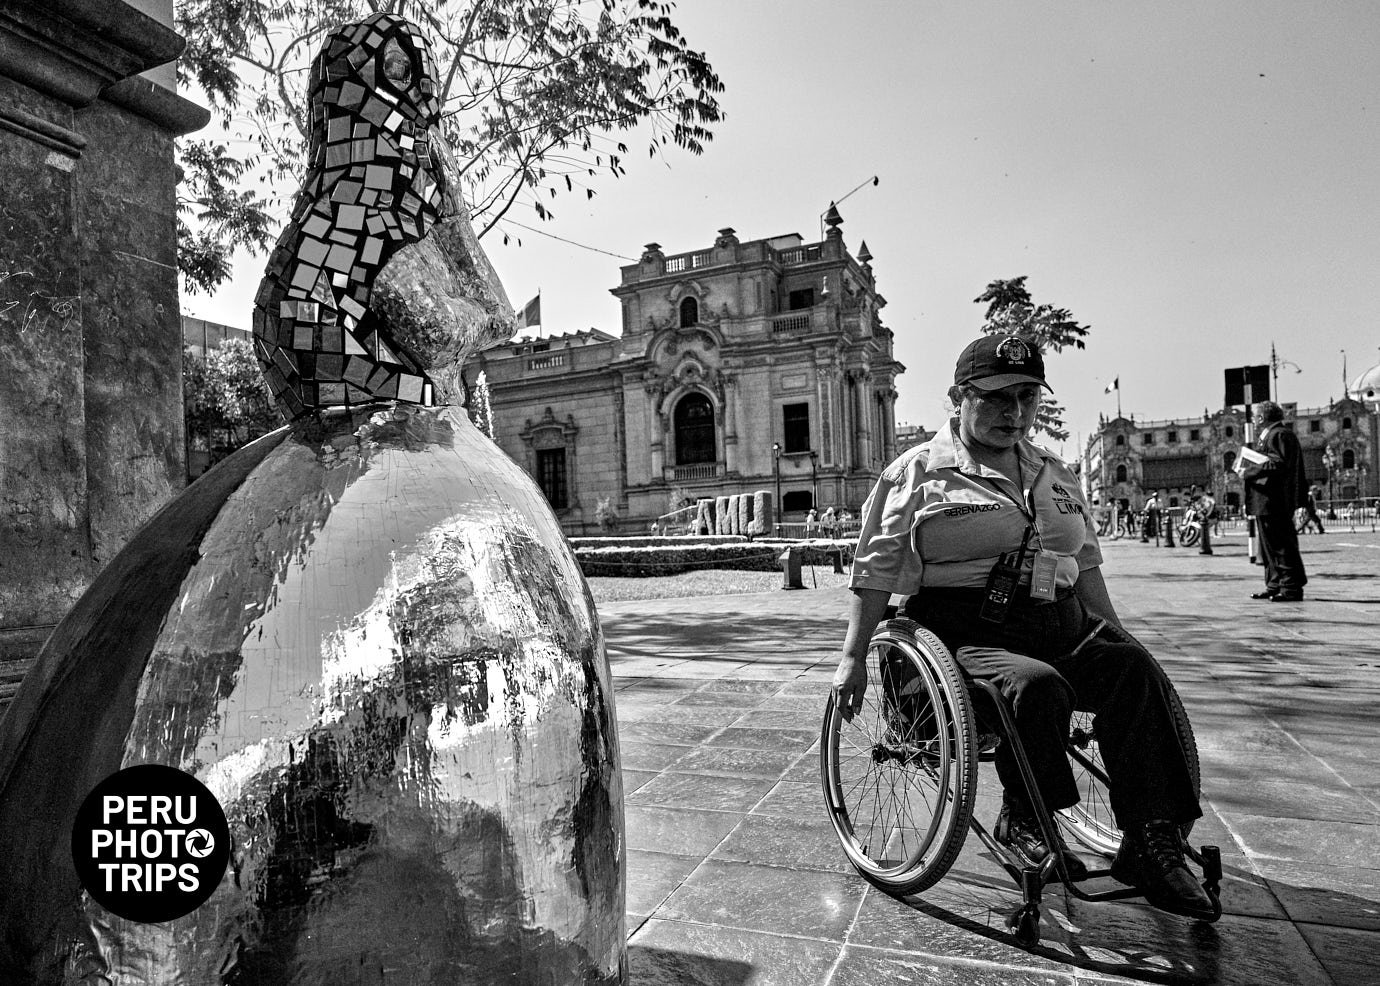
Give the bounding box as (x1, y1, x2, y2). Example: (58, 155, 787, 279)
(0, 15, 627, 986)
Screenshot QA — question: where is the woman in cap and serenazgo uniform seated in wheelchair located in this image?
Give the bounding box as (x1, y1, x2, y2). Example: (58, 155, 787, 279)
(834, 336, 1220, 920)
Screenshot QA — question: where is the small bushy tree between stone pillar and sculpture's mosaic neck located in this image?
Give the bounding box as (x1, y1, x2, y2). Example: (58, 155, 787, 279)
(182, 338, 283, 464)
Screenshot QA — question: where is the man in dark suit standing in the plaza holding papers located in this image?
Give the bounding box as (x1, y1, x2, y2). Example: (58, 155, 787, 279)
(1241, 400, 1308, 602)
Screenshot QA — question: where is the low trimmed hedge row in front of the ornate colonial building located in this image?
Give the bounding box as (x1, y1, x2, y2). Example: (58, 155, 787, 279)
(575, 539, 853, 579)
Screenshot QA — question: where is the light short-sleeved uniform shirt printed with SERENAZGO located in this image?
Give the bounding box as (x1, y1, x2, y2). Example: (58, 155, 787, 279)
(849, 418, 1103, 595)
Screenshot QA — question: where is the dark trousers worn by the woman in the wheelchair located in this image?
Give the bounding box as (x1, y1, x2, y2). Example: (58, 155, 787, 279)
(905, 590, 1202, 829)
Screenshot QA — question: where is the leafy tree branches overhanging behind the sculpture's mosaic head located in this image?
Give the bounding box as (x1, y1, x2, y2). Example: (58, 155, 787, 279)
(177, 0, 723, 289)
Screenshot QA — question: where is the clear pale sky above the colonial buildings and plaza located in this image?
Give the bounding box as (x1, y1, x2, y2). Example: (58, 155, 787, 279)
(184, 0, 1380, 454)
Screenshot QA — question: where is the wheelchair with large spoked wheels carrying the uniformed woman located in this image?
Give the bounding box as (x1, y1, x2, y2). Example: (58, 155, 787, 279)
(820, 617, 1221, 947)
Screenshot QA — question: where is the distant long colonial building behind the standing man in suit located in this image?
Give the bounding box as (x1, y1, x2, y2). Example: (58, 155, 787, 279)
(1085, 398, 1377, 510)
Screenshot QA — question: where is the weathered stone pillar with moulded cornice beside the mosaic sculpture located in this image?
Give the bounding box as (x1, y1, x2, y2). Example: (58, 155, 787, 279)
(0, 0, 207, 671)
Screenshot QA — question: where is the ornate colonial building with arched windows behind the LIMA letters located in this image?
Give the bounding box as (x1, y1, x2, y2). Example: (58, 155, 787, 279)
(466, 209, 905, 533)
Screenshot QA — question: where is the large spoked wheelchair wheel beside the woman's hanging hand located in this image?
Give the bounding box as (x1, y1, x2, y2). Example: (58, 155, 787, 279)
(820, 619, 977, 896)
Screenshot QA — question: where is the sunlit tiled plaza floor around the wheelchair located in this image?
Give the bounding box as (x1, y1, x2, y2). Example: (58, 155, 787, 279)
(600, 529, 1380, 986)
